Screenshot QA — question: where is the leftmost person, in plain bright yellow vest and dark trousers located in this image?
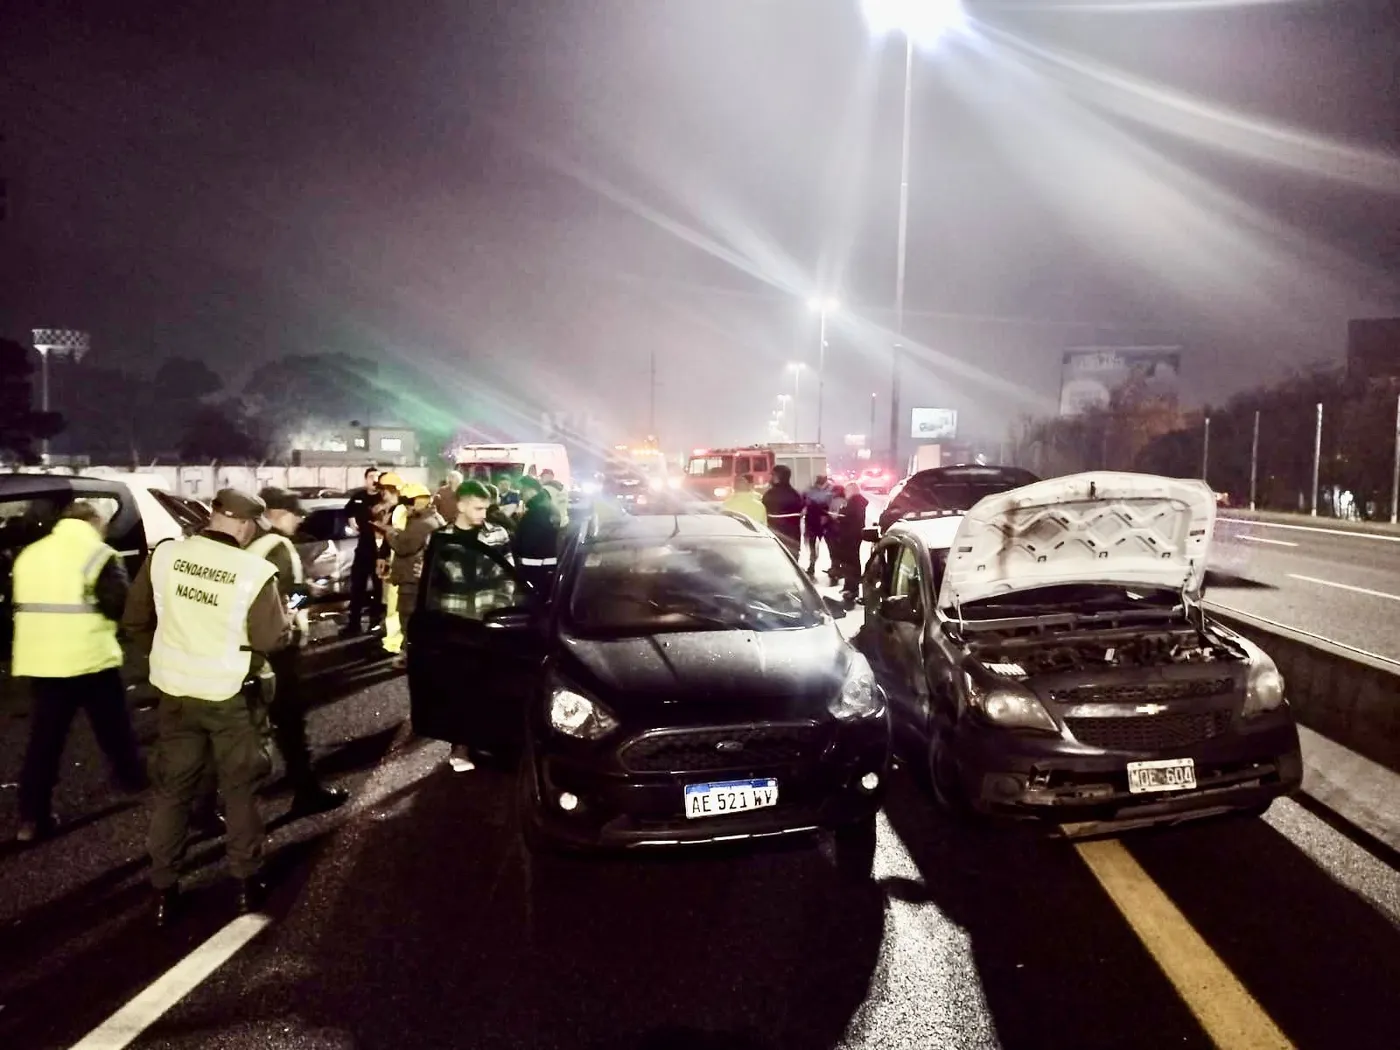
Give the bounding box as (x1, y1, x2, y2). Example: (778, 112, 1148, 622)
(11, 501, 147, 843)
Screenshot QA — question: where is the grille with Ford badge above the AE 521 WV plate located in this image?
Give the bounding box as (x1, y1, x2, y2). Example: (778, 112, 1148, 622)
(617, 722, 822, 773)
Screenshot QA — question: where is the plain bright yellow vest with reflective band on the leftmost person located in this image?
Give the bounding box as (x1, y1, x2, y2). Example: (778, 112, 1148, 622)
(11, 518, 122, 678)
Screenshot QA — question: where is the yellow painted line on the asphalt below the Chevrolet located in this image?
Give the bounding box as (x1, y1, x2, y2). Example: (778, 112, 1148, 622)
(1075, 839, 1294, 1050)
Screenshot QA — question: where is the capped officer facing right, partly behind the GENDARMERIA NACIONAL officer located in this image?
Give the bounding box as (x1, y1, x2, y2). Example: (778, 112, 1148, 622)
(248, 489, 350, 818)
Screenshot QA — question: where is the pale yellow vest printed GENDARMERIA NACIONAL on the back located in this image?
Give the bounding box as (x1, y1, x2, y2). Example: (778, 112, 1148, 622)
(151, 536, 277, 700)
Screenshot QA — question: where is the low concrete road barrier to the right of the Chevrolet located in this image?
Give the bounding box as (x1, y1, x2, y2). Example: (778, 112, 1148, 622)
(1205, 602, 1400, 773)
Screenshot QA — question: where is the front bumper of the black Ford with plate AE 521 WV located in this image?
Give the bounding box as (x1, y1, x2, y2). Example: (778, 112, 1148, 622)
(524, 717, 890, 848)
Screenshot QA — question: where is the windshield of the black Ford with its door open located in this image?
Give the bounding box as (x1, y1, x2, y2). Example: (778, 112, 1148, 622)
(567, 536, 826, 636)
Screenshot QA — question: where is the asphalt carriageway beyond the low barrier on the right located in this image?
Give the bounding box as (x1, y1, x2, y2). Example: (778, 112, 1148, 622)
(1207, 512, 1400, 659)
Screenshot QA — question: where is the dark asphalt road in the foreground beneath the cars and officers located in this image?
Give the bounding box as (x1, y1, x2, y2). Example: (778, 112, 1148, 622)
(0, 588, 1400, 1050)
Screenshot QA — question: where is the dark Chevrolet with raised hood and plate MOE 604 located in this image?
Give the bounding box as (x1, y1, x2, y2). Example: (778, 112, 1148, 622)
(858, 473, 1302, 834)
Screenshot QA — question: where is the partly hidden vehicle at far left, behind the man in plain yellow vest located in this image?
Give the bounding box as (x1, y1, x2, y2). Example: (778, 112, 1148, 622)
(0, 473, 209, 665)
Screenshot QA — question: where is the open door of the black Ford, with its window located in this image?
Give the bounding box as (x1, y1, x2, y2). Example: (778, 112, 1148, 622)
(407, 526, 545, 756)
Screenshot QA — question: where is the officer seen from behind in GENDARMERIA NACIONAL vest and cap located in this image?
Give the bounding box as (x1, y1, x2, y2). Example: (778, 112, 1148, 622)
(122, 489, 291, 925)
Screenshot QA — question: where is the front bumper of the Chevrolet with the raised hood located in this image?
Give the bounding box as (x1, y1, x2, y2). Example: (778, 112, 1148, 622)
(953, 713, 1303, 830)
